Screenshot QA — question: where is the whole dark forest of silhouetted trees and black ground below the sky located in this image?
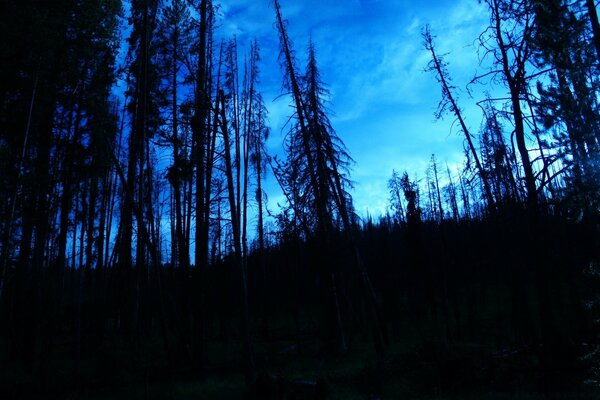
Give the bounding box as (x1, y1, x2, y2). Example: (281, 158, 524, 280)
(0, 0, 600, 400)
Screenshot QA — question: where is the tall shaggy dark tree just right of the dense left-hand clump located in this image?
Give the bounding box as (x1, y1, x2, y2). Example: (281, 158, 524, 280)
(114, 0, 163, 357)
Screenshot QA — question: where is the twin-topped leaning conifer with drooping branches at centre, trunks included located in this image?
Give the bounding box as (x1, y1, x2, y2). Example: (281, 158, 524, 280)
(274, 0, 385, 366)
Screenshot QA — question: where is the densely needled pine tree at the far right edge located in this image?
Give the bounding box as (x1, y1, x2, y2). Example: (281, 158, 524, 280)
(531, 0, 600, 210)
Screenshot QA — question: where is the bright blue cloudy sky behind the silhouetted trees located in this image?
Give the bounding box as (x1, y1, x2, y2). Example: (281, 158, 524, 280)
(213, 0, 488, 217)
